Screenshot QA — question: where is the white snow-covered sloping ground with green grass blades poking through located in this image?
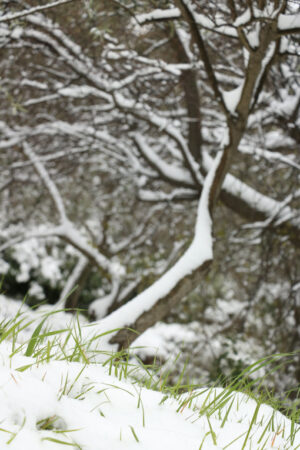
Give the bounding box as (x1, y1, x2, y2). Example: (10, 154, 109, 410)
(0, 296, 300, 450)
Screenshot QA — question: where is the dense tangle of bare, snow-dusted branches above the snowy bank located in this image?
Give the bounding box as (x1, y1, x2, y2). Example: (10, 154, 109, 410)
(0, 0, 300, 390)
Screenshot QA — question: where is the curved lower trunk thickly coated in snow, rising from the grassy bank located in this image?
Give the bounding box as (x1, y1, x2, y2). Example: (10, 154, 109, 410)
(85, 152, 223, 347)
